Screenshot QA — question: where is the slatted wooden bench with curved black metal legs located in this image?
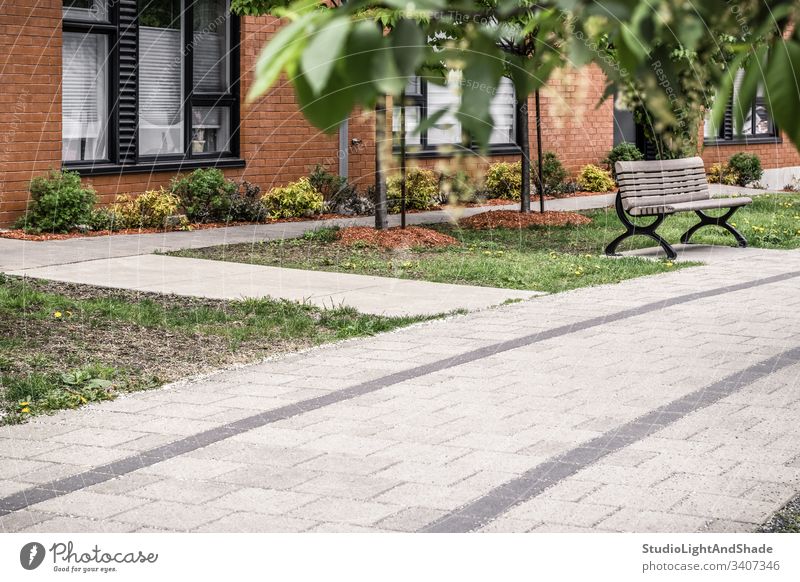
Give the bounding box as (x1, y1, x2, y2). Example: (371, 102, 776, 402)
(606, 157, 752, 259)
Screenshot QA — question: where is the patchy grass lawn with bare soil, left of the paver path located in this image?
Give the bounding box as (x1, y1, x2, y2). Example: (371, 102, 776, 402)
(0, 274, 434, 424)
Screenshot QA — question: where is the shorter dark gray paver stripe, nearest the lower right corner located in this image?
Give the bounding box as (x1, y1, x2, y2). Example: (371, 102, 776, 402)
(420, 346, 800, 533)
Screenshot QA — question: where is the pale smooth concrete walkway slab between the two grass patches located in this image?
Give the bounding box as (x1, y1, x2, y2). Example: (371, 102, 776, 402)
(10, 255, 543, 316)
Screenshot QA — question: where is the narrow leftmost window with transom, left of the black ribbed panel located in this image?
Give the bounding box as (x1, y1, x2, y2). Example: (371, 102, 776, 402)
(61, 0, 112, 161)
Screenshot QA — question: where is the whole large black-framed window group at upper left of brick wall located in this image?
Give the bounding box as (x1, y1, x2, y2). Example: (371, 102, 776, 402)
(62, 0, 243, 173)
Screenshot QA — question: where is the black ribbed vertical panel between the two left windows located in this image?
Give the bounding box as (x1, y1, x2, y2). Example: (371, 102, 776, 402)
(117, 0, 139, 164)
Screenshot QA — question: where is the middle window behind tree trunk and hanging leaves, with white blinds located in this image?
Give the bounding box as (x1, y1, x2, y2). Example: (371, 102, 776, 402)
(392, 71, 516, 154)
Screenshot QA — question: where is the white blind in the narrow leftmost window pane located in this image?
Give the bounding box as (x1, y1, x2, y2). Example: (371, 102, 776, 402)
(61, 32, 108, 161)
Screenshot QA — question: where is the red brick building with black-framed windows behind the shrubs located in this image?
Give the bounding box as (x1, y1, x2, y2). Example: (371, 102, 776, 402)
(0, 0, 800, 226)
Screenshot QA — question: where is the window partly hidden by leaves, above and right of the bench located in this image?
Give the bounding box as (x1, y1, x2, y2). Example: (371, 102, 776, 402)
(703, 70, 778, 143)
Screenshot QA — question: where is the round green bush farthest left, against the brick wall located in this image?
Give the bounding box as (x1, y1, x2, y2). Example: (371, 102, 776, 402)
(16, 170, 97, 233)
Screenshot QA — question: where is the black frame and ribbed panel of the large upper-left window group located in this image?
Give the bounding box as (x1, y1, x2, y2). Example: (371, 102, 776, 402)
(61, 0, 245, 176)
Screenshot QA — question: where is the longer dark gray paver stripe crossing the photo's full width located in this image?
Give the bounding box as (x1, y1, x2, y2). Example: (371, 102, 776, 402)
(0, 271, 800, 516)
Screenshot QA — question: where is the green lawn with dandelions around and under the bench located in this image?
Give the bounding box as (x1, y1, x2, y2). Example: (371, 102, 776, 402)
(171, 195, 800, 292)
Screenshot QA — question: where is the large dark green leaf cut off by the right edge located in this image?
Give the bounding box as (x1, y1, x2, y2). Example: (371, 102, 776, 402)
(766, 39, 800, 148)
